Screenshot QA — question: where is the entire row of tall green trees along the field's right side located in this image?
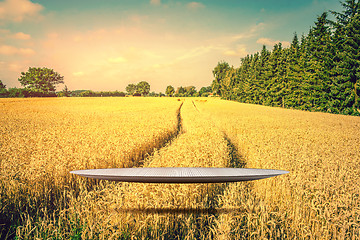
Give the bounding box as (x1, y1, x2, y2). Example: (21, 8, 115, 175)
(211, 0, 360, 115)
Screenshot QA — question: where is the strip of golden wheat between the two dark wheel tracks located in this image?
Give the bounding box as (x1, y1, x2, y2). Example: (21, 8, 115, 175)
(83, 100, 235, 239)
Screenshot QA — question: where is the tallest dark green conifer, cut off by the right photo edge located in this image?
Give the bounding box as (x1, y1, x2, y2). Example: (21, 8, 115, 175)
(331, 0, 360, 115)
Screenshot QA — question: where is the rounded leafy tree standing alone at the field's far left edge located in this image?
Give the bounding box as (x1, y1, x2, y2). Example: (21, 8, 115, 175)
(18, 67, 64, 97)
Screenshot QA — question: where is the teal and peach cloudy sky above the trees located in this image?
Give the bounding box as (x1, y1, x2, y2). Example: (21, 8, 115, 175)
(0, 0, 342, 92)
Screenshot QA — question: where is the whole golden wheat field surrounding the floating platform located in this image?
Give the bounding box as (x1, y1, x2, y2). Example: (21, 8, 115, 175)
(0, 97, 360, 239)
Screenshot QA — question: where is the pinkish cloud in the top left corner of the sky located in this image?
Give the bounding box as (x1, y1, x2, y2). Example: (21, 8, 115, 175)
(0, 0, 43, 22)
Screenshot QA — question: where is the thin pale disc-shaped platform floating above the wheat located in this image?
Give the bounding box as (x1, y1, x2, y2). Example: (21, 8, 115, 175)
(70, 168, 289, 183)
